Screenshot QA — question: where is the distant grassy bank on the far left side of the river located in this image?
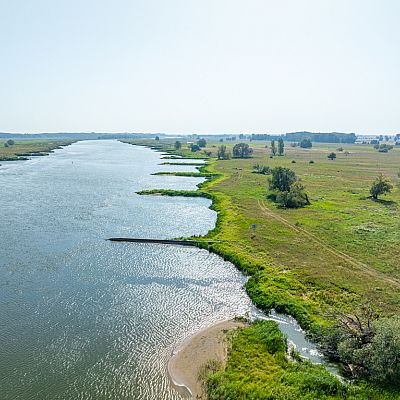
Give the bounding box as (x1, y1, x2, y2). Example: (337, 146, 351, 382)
(0, 140, 74, 161)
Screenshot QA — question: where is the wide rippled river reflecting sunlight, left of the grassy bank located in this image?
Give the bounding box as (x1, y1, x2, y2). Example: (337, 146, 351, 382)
(0, 141, 251, 400)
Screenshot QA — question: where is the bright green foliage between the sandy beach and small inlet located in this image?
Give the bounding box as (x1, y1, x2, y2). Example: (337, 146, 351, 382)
(208, 321, 349, 400)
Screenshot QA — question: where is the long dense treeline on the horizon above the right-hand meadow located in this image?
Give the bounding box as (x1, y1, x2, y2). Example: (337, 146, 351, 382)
(251, 131, 357, 143)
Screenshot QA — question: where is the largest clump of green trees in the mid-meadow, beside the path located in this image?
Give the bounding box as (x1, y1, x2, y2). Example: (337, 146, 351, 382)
(268, 167, 310, 208)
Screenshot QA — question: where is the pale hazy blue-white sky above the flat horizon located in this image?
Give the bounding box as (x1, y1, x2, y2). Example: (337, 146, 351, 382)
(0, 0, 400, 134)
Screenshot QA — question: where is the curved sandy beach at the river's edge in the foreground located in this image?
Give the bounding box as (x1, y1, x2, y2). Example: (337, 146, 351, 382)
(168, 320, 245, 399)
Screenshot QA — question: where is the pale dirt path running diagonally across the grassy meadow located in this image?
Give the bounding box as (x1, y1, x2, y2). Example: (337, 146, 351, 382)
(258, 200, 400, 288)
